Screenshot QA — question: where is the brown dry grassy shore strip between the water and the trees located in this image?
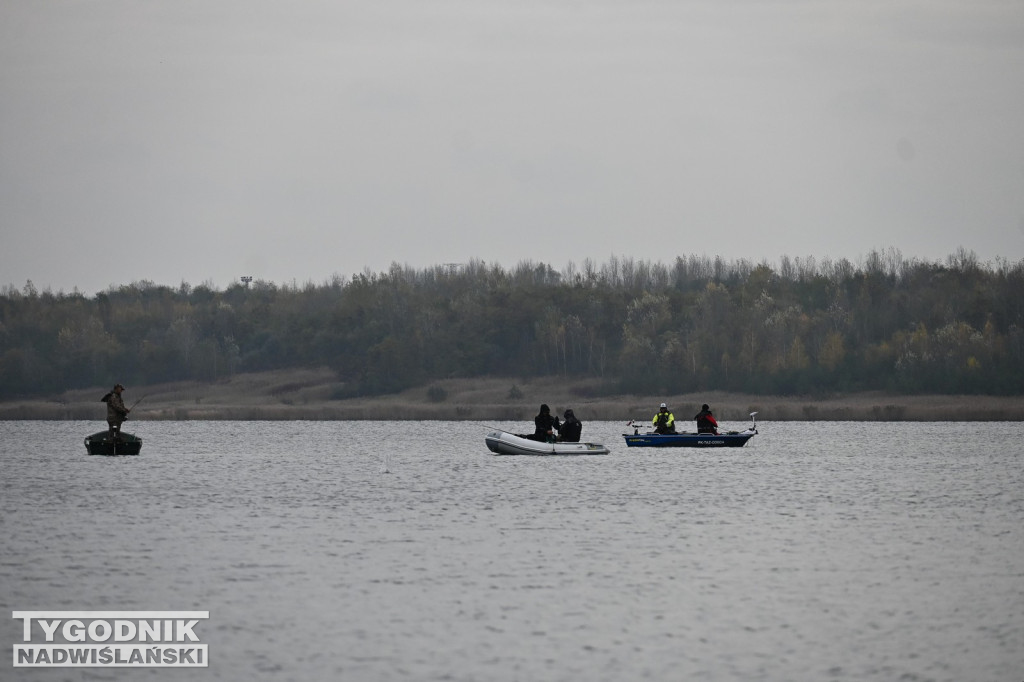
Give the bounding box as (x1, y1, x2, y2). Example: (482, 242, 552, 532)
(0, 370, 1024, 422)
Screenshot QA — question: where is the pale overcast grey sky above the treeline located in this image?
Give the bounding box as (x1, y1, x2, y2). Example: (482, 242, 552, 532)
(0, 0, 1024, 294)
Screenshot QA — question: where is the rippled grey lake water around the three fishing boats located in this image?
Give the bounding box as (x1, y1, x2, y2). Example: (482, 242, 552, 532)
(0, 413, 1024, 682)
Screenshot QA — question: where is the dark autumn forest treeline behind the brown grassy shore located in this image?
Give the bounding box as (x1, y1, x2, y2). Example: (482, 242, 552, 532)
(0, 249, 1024, 399)
